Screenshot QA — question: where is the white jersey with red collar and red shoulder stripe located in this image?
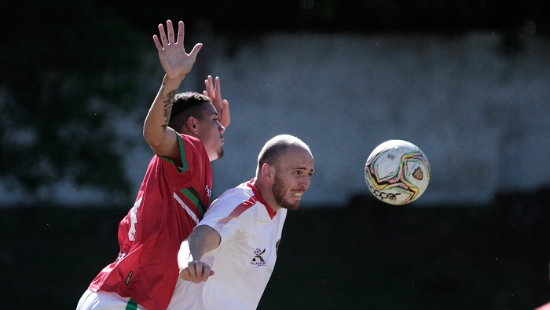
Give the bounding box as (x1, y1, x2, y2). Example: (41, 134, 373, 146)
(168, 182, 287, 310)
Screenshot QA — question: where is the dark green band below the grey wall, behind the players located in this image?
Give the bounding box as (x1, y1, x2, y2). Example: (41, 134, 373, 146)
(0, 192, 550, 310)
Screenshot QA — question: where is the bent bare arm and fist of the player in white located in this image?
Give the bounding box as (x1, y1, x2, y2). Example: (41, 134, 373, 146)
(178, 225, 221, 283)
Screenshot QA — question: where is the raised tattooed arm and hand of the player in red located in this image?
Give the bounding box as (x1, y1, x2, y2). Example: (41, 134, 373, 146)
(143, 20, 202, 159)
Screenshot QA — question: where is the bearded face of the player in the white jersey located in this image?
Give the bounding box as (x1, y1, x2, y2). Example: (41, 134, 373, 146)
(272, 146, 314, 210)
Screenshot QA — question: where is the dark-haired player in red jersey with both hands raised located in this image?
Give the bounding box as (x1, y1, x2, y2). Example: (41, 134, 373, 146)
(77, 21, 230, 310)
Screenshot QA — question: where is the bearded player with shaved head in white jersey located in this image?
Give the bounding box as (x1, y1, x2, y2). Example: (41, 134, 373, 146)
(168, 135, 314, 310)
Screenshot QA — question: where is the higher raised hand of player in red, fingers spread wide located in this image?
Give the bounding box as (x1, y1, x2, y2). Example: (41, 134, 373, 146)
(153, 20, 202, 79)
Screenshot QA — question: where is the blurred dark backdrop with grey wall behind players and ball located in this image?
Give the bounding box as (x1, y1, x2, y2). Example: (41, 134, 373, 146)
(0, 0, 550, 309)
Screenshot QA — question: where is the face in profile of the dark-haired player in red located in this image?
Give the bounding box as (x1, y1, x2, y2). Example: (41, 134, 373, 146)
(197, 103, 225, 161)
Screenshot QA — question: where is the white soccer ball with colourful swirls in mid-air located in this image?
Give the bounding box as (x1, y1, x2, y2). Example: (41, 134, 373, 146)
(365, 140, 430, 205)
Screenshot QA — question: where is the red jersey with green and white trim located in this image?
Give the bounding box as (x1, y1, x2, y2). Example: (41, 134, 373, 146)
(89, 135, 212, 310)
